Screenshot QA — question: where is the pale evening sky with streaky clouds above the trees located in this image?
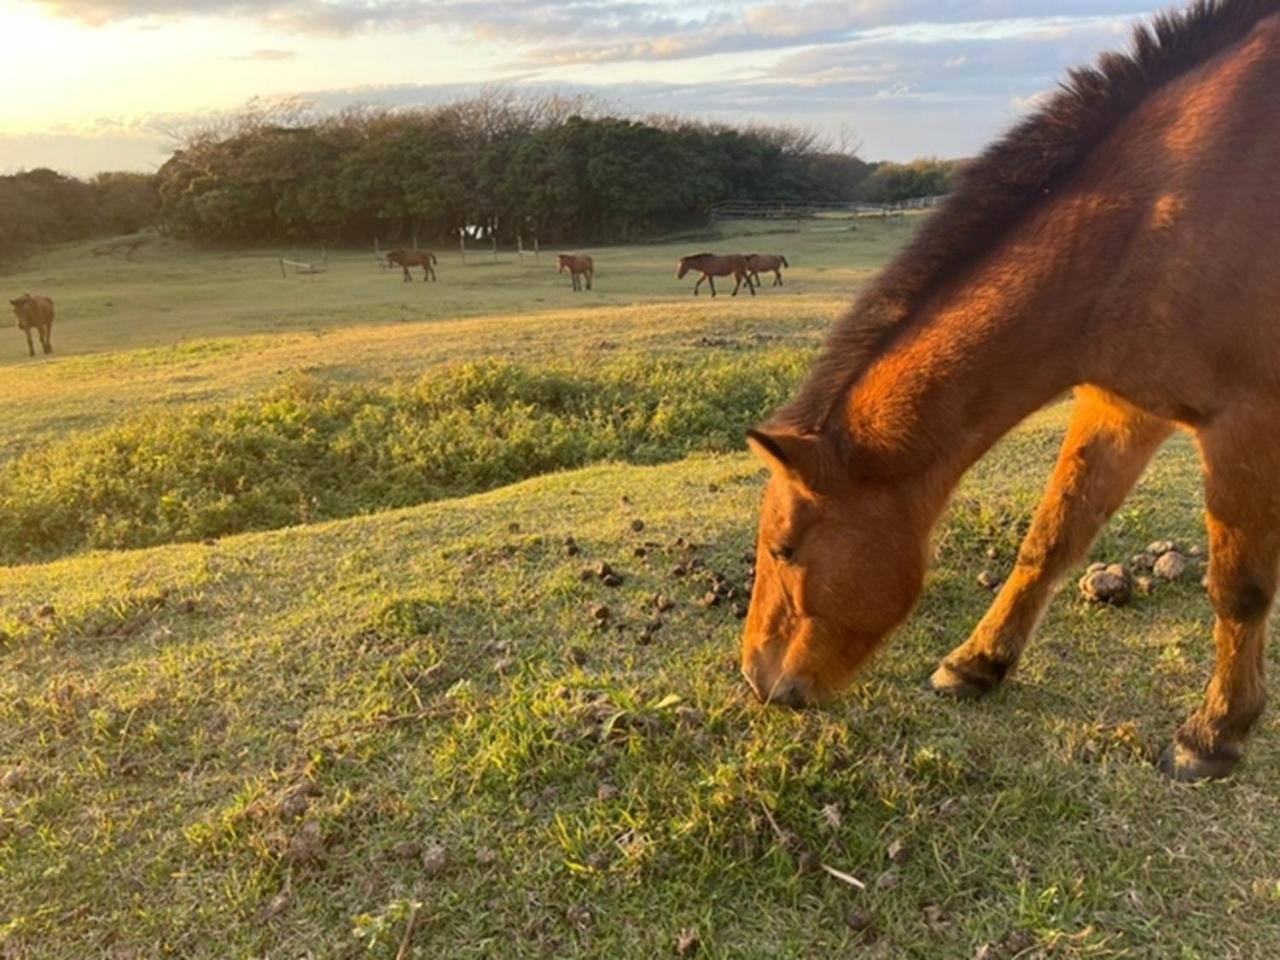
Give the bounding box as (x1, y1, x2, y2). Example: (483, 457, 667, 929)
(0, 0, 1164, 175)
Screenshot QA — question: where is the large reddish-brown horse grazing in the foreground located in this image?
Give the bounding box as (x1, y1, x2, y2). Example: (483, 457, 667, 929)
(742, 0, 1280, 780)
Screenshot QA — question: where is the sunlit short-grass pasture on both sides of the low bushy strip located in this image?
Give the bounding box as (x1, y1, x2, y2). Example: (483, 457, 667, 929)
(0, 224, 1280, 960)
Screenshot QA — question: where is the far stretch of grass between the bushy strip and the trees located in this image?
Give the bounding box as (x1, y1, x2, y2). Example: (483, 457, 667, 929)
(0, 219, 914, 457)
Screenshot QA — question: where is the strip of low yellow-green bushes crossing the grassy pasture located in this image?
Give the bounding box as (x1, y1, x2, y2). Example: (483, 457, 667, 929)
(0, 349, 809, 563)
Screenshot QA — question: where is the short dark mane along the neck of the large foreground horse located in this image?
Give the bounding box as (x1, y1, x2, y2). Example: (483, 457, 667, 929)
(773, 0, 1280, 433)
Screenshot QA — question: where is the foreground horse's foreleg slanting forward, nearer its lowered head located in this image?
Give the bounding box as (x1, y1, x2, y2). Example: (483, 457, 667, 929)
(929, 388, 1172, 698)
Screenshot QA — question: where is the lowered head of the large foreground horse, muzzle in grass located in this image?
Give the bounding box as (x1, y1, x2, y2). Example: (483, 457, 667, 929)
(742, 430, 931, 707)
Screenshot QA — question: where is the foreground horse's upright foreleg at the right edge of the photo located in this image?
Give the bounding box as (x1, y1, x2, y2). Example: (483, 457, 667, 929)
(1160, 410, 1280, 780)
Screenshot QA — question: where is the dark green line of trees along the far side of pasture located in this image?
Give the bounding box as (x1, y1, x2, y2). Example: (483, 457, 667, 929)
(0, 95, 955, 257)
